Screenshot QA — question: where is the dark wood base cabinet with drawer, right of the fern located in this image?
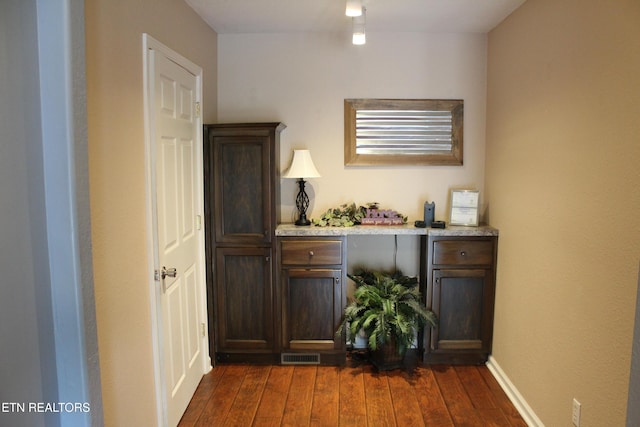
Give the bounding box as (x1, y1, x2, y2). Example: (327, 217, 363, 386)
(422, 236, 498, 364)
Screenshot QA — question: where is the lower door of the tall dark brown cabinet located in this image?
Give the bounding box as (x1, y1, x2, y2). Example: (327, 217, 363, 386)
(215, 248, 274, 352)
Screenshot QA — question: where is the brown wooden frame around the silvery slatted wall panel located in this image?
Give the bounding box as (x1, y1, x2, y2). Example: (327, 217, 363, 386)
(344, 98, 464, 166)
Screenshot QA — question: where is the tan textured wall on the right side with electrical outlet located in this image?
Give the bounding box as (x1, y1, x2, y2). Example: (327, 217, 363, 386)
(485, 0, 640, 427)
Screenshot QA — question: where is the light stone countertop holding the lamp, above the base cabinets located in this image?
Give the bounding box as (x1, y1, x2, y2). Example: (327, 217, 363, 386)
(276, 224, 498, 237)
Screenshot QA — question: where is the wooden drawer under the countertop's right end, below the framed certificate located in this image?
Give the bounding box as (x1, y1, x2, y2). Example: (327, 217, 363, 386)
(433, 240, 493, 265)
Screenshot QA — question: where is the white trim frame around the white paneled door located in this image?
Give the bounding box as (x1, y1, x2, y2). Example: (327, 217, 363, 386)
(142, 33, 211, 426)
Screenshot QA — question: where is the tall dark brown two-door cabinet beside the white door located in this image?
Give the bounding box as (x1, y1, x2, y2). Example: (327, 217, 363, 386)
(204, 123, 285, 363)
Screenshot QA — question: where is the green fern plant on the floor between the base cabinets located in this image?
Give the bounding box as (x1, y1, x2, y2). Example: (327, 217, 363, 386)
(337, 270, 438, 355)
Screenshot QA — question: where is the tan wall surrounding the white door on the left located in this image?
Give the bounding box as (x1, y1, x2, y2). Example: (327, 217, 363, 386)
(85, 0, 217, 426)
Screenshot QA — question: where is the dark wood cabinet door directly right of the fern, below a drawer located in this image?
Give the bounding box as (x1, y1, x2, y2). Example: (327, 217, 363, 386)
(427, 269, 494, 354)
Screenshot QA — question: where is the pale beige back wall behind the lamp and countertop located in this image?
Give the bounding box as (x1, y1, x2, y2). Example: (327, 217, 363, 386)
(218, 33, 487, 274)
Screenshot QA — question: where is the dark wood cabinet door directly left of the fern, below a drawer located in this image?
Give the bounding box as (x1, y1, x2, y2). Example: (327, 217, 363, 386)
(282, 269, 346, 350)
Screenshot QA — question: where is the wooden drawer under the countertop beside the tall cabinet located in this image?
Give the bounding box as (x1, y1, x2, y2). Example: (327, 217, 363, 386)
(281, 240, 342, 265)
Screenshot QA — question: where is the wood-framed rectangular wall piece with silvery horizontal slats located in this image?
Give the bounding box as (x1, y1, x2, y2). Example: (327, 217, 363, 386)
(344, 98, 464, 166)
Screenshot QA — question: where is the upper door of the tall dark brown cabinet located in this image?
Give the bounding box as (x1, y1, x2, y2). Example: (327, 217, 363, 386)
(211, 135, 273, 244)
